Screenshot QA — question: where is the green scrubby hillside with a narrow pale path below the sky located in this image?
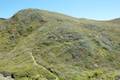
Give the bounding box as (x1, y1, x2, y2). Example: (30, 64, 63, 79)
(0, 9, 120, 80)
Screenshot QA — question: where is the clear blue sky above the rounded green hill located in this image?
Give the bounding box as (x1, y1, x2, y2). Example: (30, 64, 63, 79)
(0, 0, 120, 20)
